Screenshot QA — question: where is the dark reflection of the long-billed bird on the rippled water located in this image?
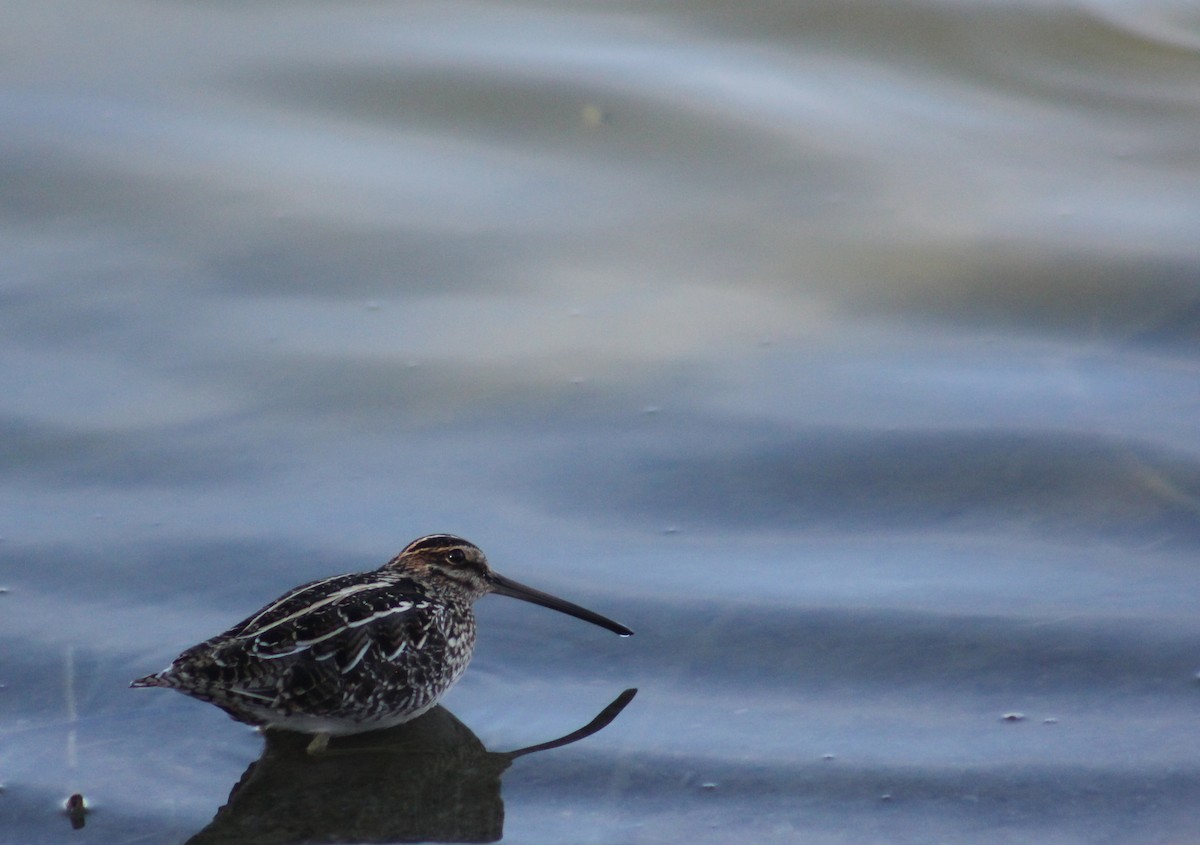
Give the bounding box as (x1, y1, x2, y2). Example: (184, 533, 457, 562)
(187, 689, 637, 845)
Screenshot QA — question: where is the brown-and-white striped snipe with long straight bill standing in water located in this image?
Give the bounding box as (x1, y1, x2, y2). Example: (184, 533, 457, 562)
(130, 534, 632, 754)
